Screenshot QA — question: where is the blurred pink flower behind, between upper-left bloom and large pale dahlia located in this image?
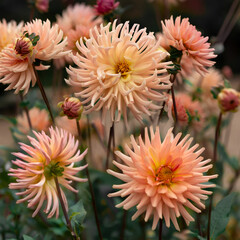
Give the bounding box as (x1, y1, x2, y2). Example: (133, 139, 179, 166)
(54, 3, 103, 68)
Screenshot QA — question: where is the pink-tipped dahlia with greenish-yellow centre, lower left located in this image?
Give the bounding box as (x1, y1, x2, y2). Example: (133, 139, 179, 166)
(9, 127, 87, 218)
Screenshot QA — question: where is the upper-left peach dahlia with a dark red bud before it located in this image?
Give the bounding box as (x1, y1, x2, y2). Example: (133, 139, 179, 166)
(0, 19, 68, 94)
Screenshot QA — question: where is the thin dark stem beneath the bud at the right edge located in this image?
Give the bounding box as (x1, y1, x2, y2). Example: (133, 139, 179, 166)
(207, 112, 222, 240)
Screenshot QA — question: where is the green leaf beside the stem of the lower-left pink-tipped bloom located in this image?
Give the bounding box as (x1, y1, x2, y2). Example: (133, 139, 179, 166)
(69, 200, 87, 236)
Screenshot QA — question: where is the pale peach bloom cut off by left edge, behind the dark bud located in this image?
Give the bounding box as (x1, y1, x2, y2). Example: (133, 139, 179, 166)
(0, 19, 23, 52)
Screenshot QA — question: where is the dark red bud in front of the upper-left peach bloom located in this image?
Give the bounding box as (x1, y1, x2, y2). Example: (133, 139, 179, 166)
(15, 37, 33, 58)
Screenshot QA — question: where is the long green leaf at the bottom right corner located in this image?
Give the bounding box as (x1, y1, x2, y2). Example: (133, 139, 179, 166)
(210, 193, 236, 240)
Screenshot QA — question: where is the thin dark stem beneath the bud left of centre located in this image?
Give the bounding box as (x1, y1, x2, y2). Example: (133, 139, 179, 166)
(76, 119, 103, 240)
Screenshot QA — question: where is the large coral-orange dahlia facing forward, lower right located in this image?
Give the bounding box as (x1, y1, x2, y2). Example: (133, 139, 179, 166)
(108, 127, 217, 230)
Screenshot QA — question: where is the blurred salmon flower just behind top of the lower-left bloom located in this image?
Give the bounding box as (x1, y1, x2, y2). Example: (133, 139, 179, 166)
(17, 107, 50, 134)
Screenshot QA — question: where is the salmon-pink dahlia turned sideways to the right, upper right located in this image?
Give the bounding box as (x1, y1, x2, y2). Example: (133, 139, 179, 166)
(161, 16, 216, 75)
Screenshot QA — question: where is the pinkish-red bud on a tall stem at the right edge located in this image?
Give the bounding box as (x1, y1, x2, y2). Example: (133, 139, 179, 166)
(218, 88, 240, 113)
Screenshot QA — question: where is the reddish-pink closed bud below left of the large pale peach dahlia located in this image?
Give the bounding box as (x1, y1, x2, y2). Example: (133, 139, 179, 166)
(58, 97, 83, 119)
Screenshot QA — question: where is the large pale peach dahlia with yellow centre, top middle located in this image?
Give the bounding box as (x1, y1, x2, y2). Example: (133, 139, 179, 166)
(66, 20, 171, 123)
